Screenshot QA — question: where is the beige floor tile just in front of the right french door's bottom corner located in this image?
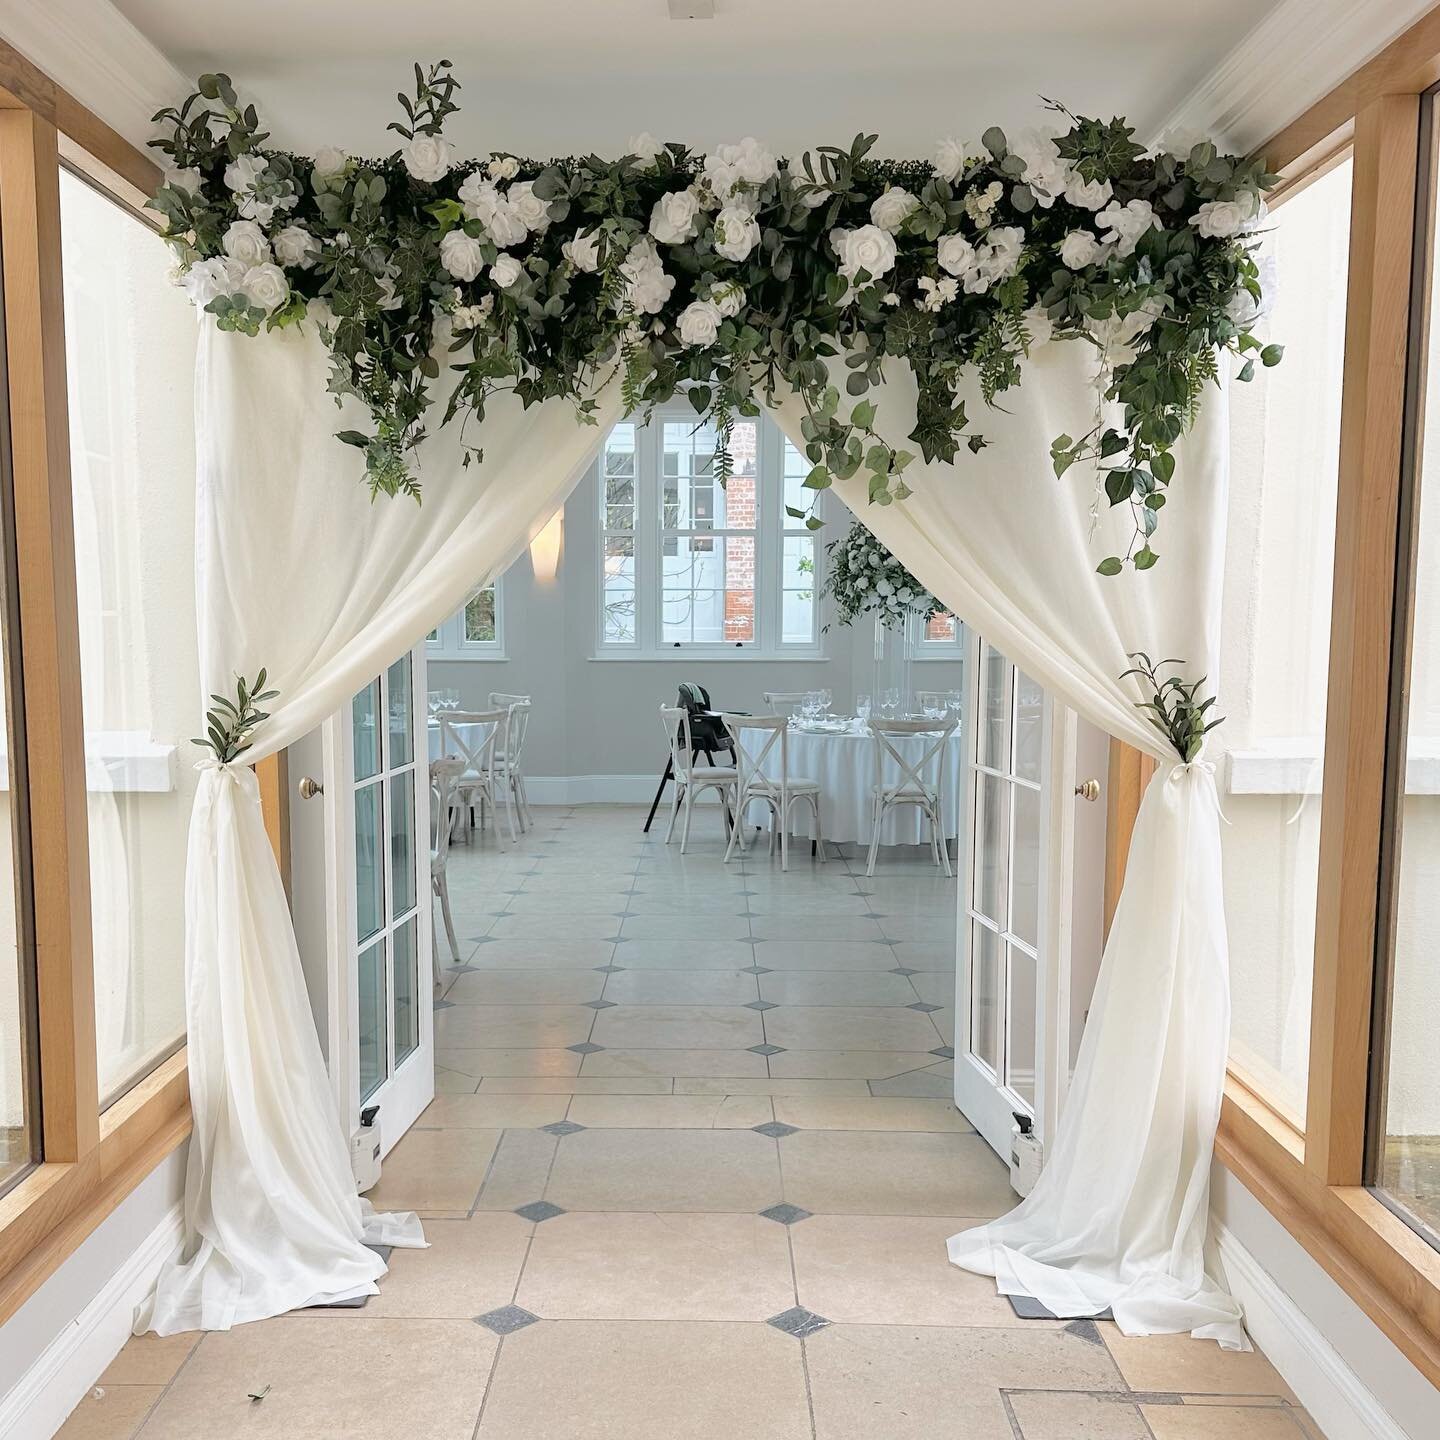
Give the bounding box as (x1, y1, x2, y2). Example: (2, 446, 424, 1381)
(780, 1130, 1019, 1215)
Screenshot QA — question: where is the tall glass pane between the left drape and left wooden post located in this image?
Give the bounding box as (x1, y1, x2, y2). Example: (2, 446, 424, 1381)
(59, 171, 200, 1104)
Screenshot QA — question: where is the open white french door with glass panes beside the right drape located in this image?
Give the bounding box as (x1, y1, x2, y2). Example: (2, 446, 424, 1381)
(955, 635, 1104, 1161)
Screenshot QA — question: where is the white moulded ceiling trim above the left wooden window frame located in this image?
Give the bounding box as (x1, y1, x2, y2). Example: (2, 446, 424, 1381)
(0, 0, 193, 154)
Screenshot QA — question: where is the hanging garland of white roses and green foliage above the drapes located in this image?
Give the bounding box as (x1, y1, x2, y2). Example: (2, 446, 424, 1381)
(143, 60, 1279, 573)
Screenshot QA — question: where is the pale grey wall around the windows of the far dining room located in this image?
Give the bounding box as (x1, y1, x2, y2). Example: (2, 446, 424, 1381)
(429, 472, 960, 778)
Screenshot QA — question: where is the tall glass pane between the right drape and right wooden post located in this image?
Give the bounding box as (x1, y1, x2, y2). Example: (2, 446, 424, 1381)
(1211, 158, 1351, 1126)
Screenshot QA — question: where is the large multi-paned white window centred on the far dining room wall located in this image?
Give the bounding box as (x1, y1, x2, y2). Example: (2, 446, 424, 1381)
(599, 406, 819, 658)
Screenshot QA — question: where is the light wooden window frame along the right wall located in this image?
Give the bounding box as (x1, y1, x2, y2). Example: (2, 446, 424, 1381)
(1106, 9, 1440, 1385)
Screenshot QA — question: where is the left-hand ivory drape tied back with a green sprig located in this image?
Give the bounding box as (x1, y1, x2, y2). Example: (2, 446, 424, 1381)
(135, 317, 619, 1335)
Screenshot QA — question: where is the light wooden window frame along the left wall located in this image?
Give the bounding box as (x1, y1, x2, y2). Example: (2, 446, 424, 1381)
(0, 42, 289, 1323)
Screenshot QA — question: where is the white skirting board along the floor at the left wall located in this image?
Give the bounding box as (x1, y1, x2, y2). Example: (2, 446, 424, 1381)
(0, 1205, 184, 1440)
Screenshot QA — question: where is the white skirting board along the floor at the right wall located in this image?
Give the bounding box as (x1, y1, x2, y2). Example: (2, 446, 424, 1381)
(1210, 1217, 1420, 1440)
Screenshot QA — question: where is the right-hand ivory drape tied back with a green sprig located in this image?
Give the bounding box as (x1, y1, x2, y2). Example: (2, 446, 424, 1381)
(778, 341, 1248, 1348)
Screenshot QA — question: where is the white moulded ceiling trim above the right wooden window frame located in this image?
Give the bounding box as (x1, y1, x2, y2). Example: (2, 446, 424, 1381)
(1159, 0, 1434, 154)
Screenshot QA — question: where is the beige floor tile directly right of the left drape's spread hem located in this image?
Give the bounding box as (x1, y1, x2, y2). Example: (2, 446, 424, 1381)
(304, 1214, 534, 1319)
